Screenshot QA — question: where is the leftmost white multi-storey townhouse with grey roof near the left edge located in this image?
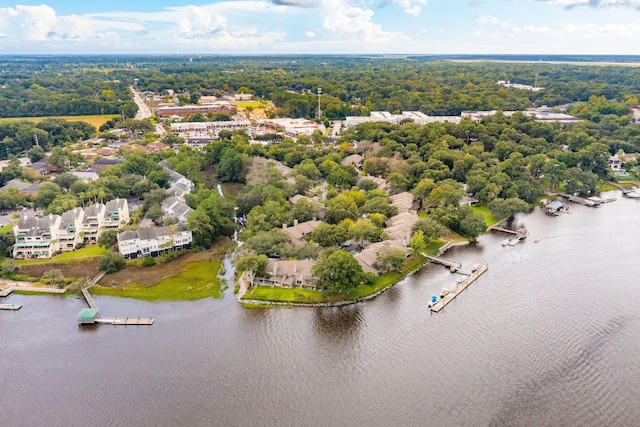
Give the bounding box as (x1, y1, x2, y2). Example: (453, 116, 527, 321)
(13, 215, 61, 258)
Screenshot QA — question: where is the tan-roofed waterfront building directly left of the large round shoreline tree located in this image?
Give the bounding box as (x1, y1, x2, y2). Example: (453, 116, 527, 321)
(252, 258, 317, 290)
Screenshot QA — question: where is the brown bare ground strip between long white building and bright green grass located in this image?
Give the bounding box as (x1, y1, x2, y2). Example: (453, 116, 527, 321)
(99, 237, 231, 288)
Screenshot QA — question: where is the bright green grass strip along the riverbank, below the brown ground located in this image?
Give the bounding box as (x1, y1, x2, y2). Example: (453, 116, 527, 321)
(91, 259, 222, 301)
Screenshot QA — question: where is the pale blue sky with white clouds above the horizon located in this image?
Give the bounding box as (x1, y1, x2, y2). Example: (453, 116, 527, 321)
(0, 0, 640, 55)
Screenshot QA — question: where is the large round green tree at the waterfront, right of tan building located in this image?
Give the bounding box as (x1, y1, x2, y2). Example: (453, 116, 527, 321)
(312, 250, 363, 295)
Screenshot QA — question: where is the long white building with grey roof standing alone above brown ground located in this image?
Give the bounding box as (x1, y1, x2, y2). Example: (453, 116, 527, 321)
(118, 224, 193, 258)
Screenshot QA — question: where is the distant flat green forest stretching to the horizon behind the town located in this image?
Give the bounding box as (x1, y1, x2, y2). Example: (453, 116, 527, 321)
(0, 56, 640, 120)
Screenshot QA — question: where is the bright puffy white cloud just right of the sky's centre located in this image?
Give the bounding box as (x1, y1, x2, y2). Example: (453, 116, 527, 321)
(320, 0, 408, 44)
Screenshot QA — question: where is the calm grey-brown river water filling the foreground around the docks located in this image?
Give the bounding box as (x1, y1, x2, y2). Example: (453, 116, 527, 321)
(0, 193, 640, 426)
